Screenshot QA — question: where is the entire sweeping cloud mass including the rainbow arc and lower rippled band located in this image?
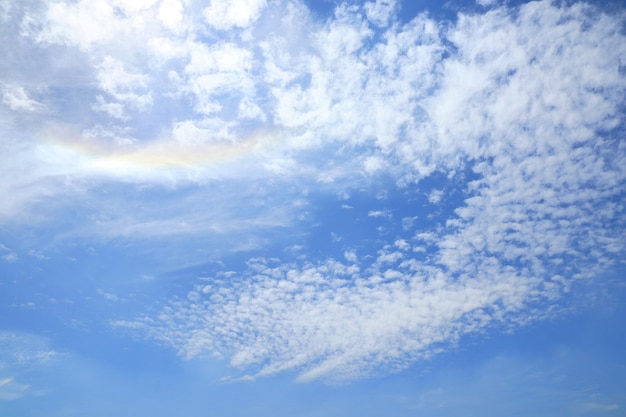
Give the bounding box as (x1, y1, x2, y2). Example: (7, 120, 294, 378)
(0, 0, 626, 383)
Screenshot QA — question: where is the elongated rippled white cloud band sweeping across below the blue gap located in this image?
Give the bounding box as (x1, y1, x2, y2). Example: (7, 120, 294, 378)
(120, 247, 533, 381)
